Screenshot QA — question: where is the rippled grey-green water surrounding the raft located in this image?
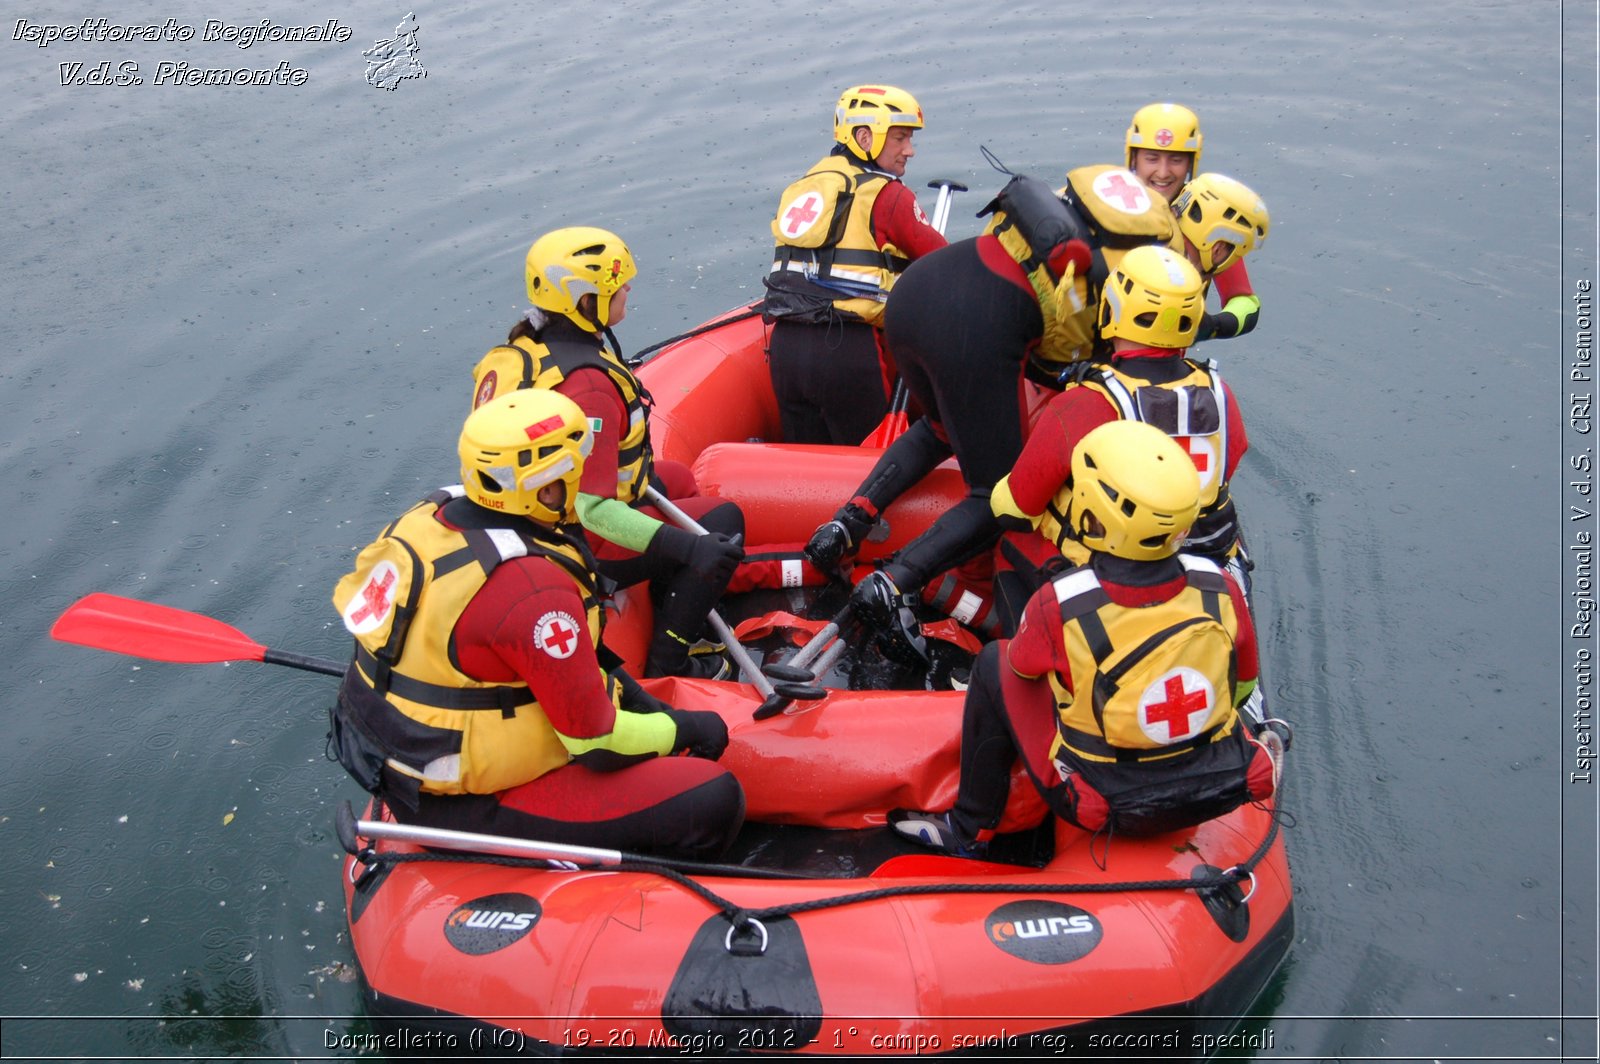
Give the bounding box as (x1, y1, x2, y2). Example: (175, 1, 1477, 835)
(0, 0, 1597, 1061)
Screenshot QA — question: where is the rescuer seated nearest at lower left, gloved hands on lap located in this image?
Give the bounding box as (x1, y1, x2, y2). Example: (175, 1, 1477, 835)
(330, 389, 744, 858)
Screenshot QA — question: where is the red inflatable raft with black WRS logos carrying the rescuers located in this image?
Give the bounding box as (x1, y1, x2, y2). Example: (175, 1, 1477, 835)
(341, 305, 1293, 1059)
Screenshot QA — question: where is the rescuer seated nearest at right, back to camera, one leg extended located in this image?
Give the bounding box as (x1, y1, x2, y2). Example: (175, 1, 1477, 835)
(890, 421, 1277, 856)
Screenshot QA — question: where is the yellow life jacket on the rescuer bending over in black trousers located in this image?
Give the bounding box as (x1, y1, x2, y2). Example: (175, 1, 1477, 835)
(984, 165, 1182, 368)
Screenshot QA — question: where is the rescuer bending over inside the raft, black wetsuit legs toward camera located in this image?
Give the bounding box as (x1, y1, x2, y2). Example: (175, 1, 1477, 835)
(806, 166, 1248, 659)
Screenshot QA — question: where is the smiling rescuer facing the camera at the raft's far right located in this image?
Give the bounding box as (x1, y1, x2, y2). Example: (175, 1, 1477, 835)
(1125, 104, 1267, 339)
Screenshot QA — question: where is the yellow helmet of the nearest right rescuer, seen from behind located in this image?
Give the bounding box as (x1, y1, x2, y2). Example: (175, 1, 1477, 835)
(1069, 421, 1200, 562)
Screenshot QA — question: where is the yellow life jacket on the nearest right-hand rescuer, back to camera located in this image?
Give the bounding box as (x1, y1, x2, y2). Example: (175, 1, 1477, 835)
(1048, 555, 1238, 763)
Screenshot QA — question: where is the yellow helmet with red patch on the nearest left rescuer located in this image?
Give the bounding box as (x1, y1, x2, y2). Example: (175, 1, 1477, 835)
(458, 387, 594, 525)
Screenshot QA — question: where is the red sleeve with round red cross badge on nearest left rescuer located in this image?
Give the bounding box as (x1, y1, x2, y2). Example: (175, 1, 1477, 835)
(454, 558, 616, 739)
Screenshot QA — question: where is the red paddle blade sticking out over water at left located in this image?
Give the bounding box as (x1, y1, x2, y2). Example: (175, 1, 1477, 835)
(50, 592, 267, 664)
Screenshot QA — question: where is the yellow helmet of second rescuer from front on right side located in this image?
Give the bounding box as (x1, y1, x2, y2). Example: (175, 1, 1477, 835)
(1099, 243, 1205, 347)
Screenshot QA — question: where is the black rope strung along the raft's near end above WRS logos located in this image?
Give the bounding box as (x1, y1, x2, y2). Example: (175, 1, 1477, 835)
(354, 790, 1294, 950)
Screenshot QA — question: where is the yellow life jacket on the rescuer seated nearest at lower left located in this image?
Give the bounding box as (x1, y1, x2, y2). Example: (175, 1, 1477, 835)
(333, 485, 621, 805)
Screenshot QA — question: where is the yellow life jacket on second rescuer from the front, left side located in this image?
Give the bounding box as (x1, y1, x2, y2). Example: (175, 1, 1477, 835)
(472, 323, 654, 504)
